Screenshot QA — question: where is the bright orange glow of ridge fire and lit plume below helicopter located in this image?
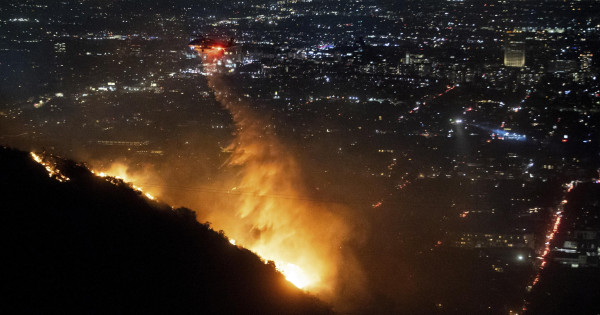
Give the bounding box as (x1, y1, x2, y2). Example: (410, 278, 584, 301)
(81, 47, 365, 304)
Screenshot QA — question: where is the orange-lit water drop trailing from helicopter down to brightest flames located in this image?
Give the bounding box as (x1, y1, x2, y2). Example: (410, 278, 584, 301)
(185, 52, 360, 298)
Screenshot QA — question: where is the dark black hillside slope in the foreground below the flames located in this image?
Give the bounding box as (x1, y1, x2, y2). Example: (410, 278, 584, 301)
(0, 148, 330, 314)
